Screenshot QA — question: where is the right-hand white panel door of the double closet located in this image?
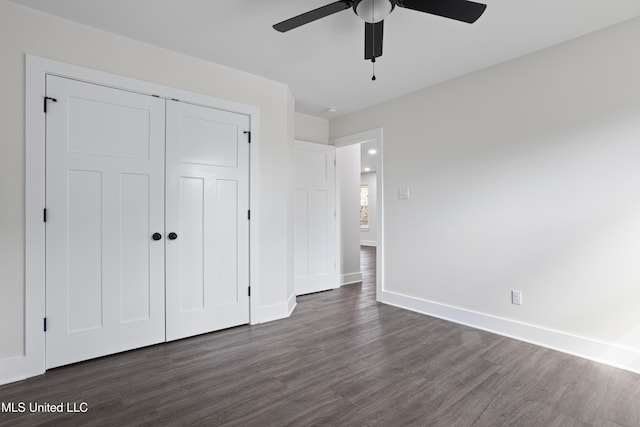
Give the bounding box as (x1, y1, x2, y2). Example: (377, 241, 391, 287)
(166, 101, 249, 341)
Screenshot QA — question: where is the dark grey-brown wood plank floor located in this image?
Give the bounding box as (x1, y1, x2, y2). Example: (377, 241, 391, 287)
(0, 248, 640, 427)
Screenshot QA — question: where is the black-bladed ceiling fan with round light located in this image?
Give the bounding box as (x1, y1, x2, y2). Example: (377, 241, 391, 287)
(273, 0, 487, 62)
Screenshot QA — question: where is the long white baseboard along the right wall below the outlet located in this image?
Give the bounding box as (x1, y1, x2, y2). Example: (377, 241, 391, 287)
(382, 291, 640, 374)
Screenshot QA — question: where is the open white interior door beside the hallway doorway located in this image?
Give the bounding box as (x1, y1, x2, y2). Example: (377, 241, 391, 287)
(294, 141, 337, 295)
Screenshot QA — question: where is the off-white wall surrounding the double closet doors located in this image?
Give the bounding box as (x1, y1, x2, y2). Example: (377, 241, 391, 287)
(0, 0, 294, 368)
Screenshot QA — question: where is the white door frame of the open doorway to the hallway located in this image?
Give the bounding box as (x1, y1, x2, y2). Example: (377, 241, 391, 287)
(330, 128, 385, 302)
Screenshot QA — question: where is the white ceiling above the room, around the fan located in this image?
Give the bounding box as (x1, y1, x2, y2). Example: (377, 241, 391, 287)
(11, 0, 640, 118)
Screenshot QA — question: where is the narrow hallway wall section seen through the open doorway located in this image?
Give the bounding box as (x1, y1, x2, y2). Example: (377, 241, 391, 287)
(336, 144, 362, 284)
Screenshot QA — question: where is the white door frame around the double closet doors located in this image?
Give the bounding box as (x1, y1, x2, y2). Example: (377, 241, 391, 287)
(25, 54, 260, 378)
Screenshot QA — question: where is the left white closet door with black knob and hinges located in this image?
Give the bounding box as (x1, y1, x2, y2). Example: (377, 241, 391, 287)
(46, 76, 165, 368)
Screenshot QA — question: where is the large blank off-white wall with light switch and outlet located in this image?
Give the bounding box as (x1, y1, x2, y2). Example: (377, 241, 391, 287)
(330, 18, 640, 371)
